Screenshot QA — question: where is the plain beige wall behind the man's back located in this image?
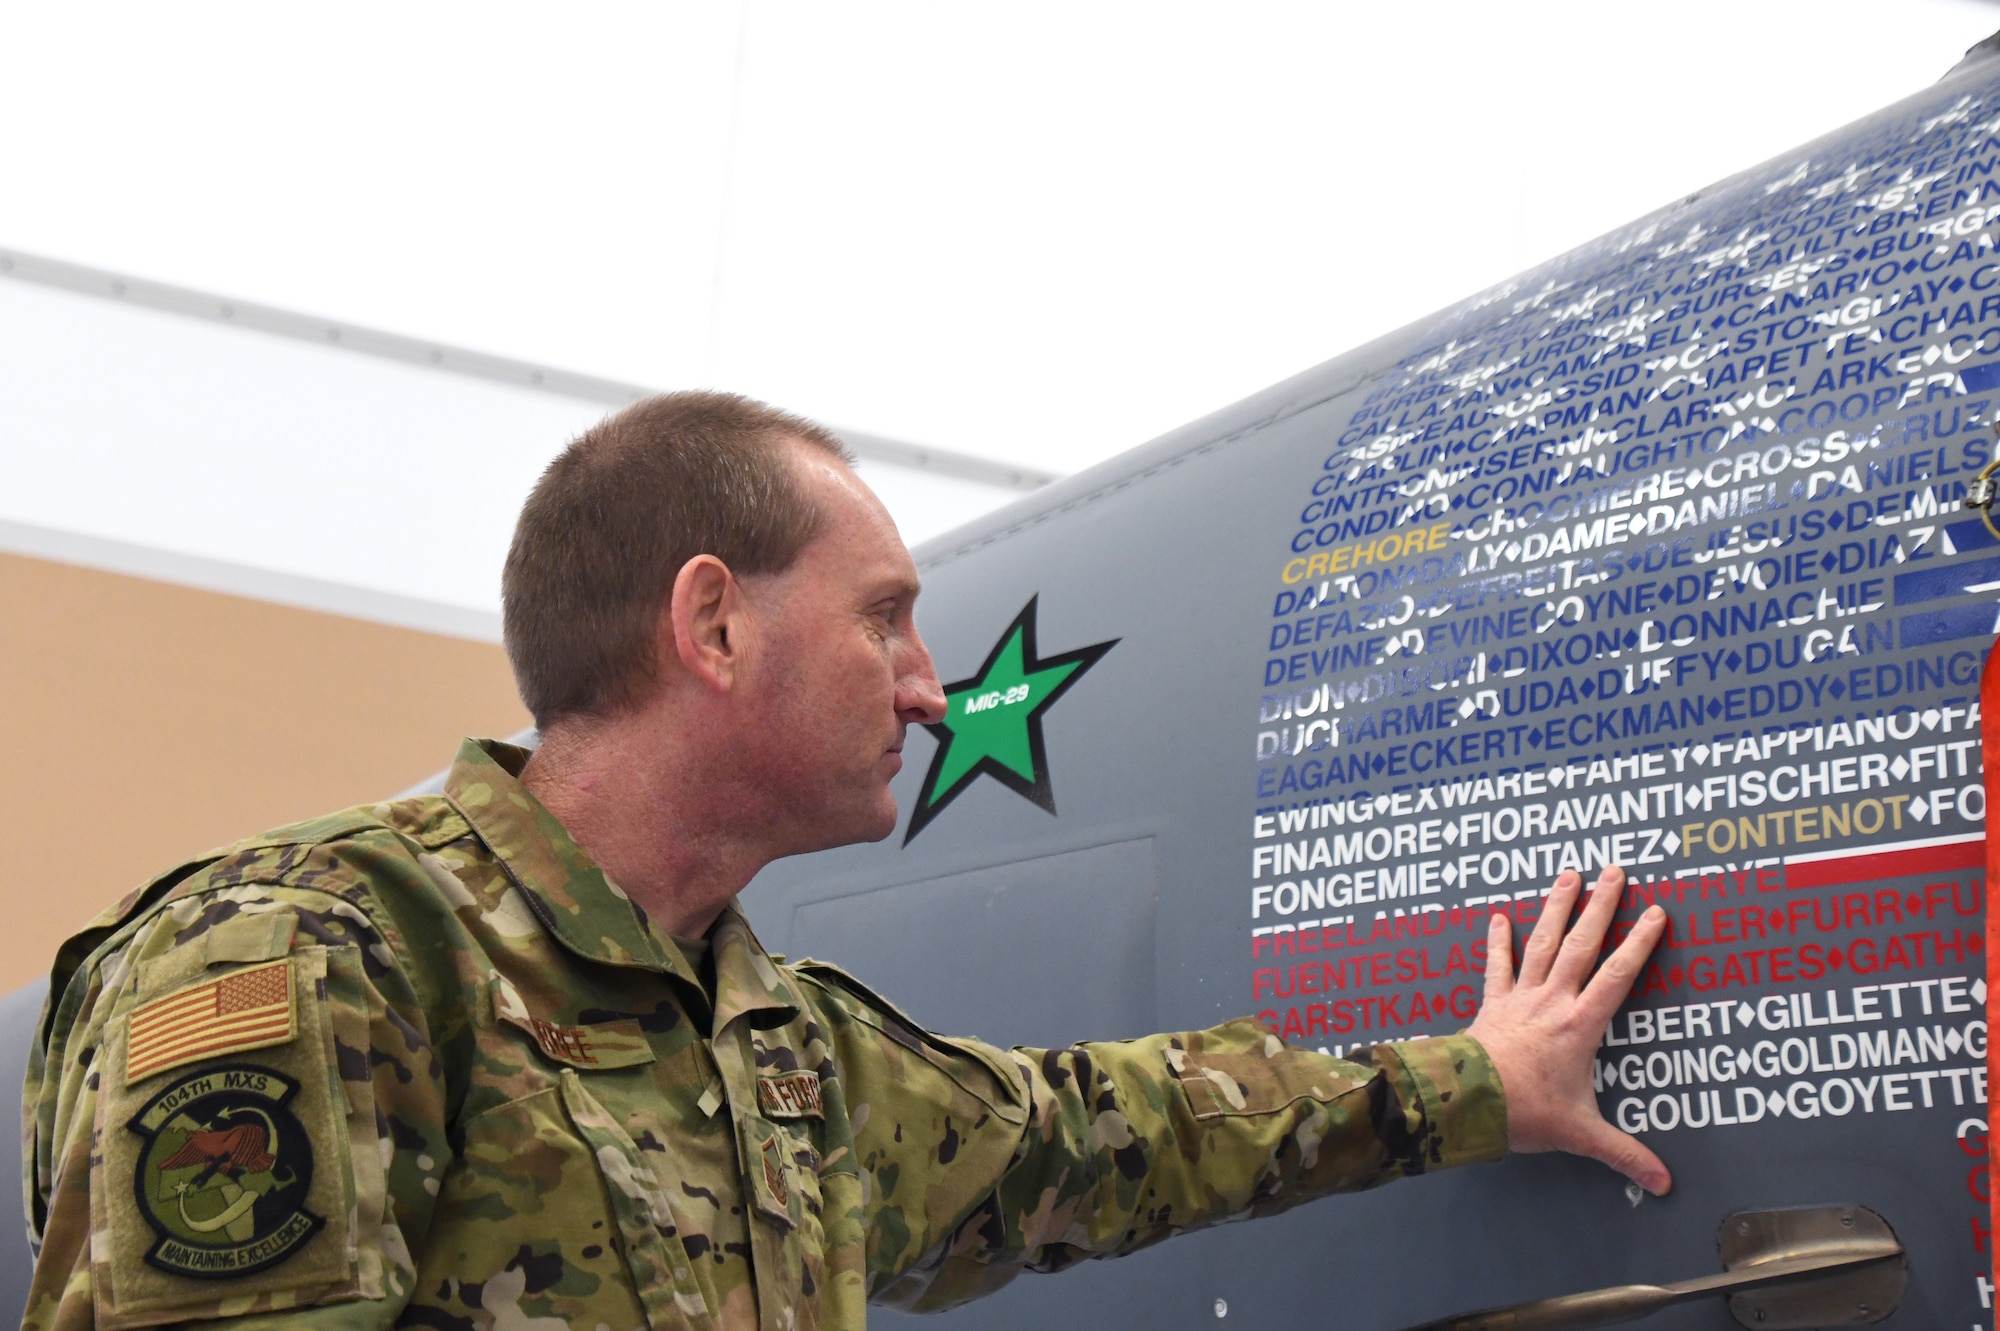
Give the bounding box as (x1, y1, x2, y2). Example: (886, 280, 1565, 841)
(0, 554, 528, 991)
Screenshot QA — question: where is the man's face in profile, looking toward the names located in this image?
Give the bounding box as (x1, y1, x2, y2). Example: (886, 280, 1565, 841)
(746, 446, 944, 853)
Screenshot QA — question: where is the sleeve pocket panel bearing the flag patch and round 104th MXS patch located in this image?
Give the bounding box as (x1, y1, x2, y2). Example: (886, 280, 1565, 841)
(87, 945, 386, 1331)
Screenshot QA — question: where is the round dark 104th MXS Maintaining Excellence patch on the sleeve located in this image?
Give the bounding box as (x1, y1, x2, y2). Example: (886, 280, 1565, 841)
(126, 1065, 326, 1279)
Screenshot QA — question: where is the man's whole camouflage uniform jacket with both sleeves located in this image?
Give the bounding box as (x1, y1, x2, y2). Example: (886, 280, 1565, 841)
(26, 741, 1506, 1331)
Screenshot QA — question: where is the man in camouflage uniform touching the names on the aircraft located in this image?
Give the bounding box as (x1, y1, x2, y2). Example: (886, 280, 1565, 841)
(26, 394, 1668, 1331)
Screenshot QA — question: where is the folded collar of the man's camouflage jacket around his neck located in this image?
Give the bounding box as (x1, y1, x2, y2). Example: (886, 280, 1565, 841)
(444, 739, 800, 1031)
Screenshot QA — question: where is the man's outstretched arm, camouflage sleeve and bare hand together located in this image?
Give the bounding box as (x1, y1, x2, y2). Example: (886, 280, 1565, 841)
(794, 869, 1668, 1311)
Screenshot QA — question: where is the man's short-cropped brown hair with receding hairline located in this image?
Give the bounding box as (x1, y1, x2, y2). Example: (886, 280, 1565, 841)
(500, 392, 854, 729)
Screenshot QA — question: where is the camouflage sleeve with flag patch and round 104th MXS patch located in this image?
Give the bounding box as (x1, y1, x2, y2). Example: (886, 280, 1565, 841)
(22, 877, 450, 1331)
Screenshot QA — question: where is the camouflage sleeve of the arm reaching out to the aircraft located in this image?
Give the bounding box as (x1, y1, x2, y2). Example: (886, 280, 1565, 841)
(806, 967, 1506, 1311)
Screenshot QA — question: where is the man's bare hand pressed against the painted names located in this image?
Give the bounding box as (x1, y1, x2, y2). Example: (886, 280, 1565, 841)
(1466, 865, 1674, 1195)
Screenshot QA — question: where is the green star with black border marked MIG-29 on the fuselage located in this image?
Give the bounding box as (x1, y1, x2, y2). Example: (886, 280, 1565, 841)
(902, 596, 1118, 845)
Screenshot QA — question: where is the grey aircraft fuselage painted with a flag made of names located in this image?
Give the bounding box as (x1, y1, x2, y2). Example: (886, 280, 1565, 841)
(748, 36, 2000, 1329)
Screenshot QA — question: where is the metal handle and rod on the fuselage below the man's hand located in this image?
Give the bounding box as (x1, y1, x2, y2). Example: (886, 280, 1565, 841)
(1408, 1205, 1908, 1331)
